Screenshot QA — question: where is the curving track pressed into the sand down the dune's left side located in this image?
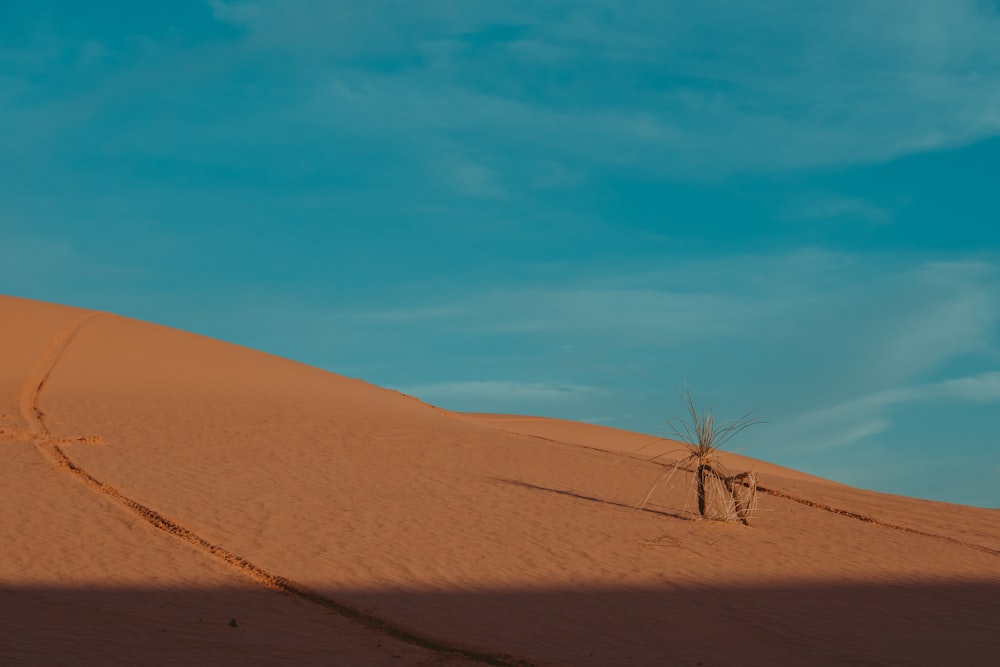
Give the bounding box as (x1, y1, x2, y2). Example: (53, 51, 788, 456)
(18, 311, 534, 667)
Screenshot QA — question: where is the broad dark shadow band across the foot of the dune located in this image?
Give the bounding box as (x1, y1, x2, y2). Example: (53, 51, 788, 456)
(0, 581, 1000, 665)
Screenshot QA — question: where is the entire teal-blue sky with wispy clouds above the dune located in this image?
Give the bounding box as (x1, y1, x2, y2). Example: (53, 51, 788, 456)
(0, 0, 1000, 507)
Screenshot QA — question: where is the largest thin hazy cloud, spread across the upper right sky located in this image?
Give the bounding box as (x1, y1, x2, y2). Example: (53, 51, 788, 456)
(212, 0, 1000, 177)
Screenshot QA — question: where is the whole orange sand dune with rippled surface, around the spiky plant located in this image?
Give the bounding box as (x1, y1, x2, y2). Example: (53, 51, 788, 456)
(0, 297, 1000, 665)
